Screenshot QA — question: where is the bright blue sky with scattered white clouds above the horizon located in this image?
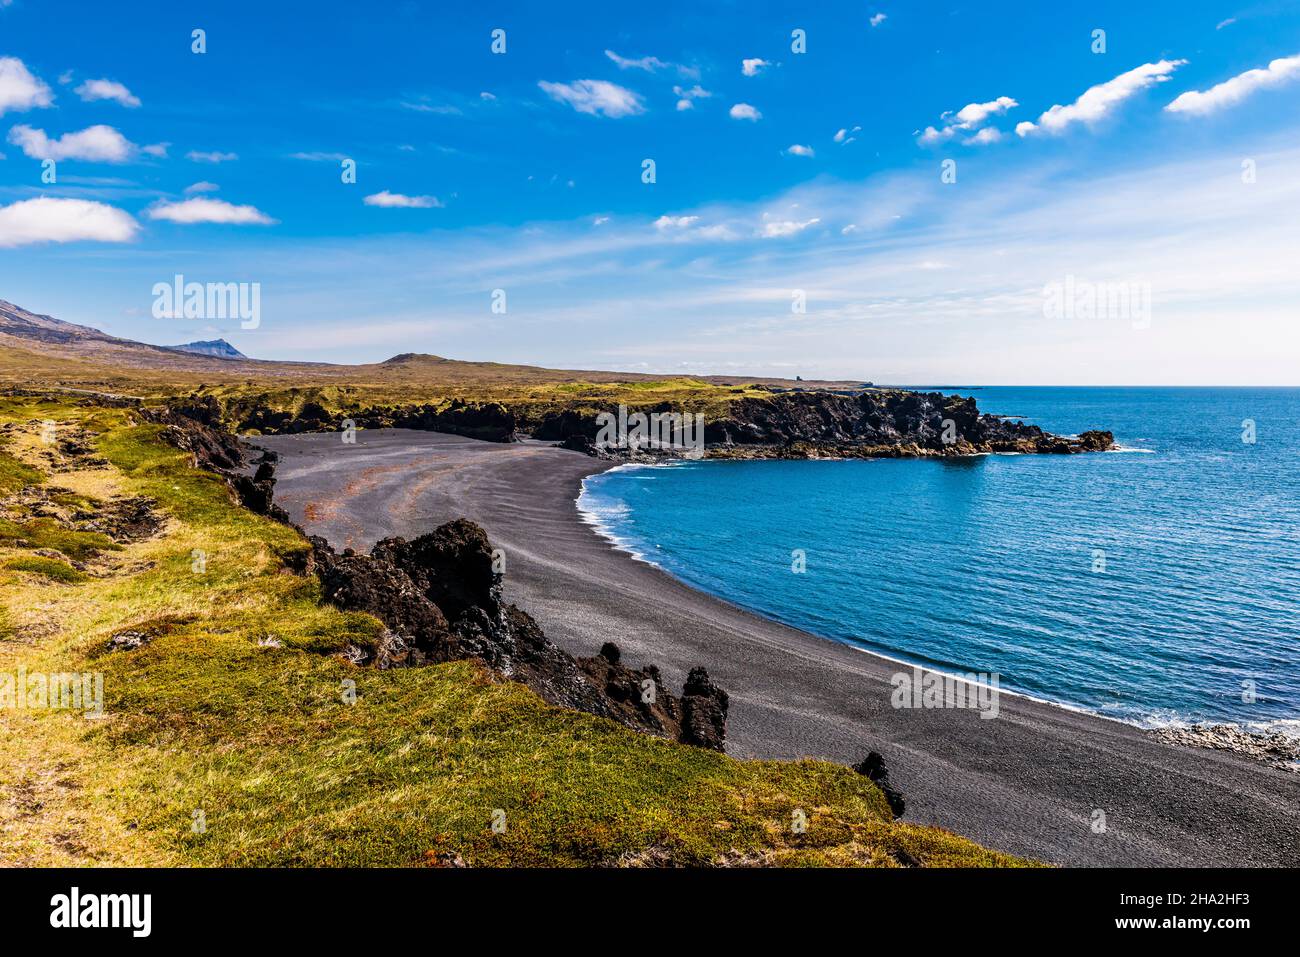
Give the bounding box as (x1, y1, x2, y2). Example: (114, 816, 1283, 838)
(0, 0, 1300, 384)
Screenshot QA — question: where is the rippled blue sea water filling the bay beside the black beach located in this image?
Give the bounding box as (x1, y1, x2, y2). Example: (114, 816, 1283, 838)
(579, 386, 1300, 732)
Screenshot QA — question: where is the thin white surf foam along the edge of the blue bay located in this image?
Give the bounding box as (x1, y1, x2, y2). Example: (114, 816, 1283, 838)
(573, 460, 1300, 743)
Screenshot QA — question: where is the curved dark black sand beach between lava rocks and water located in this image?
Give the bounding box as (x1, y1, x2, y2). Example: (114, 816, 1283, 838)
(256, 429, 1300, 866)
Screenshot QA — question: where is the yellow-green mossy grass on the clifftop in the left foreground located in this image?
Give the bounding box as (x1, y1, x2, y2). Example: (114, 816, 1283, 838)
(0, 398, 1023, 866)
